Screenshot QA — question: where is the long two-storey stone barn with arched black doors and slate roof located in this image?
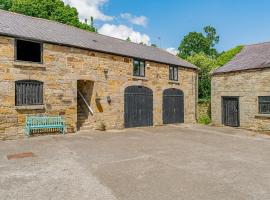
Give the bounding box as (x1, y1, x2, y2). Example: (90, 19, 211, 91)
(0, 11, 197, 138)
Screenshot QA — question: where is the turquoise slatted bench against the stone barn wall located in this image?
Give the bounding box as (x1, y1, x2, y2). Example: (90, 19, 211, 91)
(25, 116, 65, 136)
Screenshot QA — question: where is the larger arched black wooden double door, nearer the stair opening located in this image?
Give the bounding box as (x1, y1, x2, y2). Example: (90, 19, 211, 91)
(124, 86, 153, 128)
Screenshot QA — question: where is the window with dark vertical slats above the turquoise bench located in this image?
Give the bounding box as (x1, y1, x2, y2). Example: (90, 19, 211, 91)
(15, 80, 43, 106)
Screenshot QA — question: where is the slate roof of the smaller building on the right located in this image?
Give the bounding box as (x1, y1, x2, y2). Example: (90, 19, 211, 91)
(213, 42, 270, 75)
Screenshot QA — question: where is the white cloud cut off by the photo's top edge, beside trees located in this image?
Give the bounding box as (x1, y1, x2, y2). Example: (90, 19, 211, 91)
(64, 0, 114, 21)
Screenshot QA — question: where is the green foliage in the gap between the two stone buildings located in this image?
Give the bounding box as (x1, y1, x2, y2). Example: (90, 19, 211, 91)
(187, 53, 215, 99)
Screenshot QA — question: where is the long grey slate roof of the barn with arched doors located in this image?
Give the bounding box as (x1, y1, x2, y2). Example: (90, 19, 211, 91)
(0, 10, 196, 68)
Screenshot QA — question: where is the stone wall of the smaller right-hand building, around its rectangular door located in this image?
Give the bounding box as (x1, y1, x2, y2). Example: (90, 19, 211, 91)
(211, 69, 270, 130)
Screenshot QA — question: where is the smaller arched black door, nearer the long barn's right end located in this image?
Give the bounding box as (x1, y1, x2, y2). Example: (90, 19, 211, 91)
(163, 88, 184, 124)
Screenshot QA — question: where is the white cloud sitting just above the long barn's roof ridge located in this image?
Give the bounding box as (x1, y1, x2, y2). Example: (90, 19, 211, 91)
(98, 24, 150, 45)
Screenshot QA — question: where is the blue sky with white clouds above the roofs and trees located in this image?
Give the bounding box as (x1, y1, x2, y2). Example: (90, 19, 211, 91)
(64, 0, 270, 54)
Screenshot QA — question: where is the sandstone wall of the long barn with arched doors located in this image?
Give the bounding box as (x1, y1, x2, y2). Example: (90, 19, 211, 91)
(0, 36, 197, 138)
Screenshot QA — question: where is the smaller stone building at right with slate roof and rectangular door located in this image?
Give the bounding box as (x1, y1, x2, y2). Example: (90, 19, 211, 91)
(211, 43, 270, 130)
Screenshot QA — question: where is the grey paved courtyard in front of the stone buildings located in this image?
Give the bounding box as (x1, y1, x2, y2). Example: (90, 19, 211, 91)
(0, 125, 270, 200)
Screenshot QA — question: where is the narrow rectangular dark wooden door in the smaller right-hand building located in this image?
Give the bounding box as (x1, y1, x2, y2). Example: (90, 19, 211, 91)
(222, 97, 240, 127)
